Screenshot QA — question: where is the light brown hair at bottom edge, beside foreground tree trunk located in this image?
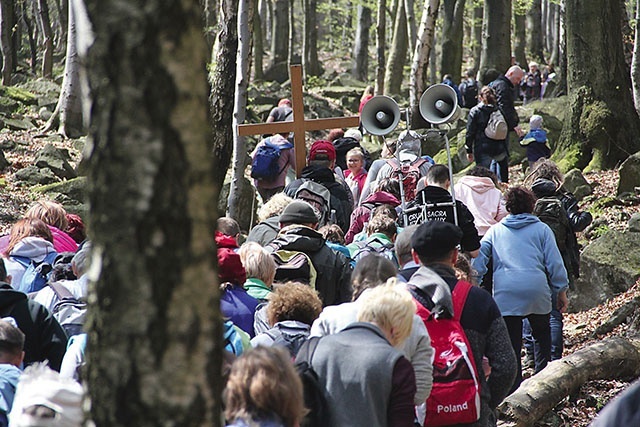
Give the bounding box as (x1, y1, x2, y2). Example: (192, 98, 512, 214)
(224, 346, 307, 427)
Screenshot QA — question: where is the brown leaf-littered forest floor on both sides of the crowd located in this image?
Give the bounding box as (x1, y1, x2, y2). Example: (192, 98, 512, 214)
(0, 122, 640, 427)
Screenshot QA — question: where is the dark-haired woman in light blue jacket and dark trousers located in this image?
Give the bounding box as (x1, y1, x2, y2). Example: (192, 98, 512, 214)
(473, 186, 568, 390)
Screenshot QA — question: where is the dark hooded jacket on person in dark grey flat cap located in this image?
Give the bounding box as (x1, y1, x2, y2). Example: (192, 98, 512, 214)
(267, 225, 352, 306)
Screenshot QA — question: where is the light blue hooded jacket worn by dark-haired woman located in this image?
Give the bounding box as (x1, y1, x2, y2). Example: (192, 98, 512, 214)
(472, 214, 569, 316)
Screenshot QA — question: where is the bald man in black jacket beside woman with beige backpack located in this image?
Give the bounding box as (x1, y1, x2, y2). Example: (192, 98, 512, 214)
(489, 65, 524, 183)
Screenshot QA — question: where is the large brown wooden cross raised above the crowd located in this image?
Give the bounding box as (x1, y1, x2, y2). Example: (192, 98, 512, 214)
(238, 65, 360, 177)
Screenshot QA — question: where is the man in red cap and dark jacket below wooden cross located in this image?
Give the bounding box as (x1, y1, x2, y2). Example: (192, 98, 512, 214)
(284, 140, 353, 233)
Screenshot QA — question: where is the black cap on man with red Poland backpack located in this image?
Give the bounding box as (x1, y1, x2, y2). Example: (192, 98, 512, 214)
(411, 221, 462, 259)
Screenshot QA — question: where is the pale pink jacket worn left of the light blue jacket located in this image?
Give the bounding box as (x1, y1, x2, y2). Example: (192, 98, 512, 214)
(454, 176, 509, 236)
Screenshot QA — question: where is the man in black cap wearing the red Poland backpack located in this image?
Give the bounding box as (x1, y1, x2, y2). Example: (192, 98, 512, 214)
(409, 221, 517, 427)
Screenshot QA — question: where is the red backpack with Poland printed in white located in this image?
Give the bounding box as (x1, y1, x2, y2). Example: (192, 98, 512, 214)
(409, 280, 480, 426)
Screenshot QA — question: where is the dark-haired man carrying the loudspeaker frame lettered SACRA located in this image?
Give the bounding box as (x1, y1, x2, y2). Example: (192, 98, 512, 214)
(409, 165, 480, 258)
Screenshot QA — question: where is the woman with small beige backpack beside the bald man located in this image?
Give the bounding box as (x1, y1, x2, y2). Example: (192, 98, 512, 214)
(464, 86, 509, 182)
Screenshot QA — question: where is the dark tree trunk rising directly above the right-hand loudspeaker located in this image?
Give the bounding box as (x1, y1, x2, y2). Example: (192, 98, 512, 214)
(440, 0, 465, 82)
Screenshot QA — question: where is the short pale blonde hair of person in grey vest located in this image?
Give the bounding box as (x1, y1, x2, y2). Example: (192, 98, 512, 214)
(358, 277, 416, 346)
